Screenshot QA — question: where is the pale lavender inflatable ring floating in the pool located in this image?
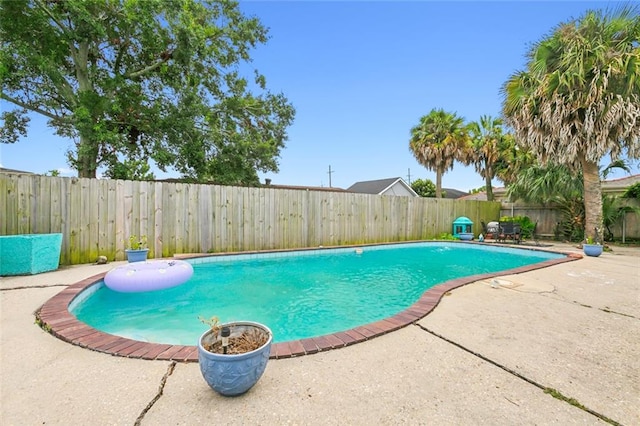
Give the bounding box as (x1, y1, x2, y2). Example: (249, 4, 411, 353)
(104, 260, 193, 293)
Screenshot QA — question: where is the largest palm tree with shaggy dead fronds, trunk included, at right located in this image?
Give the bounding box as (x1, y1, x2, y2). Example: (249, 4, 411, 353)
(503, 7, 640, 241)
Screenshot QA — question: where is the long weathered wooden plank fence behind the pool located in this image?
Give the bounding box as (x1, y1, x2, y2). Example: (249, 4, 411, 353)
(0, 173, 500, 265)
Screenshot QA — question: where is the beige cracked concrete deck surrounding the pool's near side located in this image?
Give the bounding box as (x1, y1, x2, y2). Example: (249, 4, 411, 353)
(0, 243, 640, 425)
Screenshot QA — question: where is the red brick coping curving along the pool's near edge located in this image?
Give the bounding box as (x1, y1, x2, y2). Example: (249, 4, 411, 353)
(35, 248, 582, 362)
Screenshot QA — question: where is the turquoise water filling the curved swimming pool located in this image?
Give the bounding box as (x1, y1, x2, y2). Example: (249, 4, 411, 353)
(70, 242, 563, 345)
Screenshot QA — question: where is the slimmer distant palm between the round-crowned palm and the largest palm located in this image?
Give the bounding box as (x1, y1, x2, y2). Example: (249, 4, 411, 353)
(467, 115, 506, 201)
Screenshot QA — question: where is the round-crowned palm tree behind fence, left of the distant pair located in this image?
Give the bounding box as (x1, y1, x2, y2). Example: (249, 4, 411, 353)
(409, 108, 468, 198)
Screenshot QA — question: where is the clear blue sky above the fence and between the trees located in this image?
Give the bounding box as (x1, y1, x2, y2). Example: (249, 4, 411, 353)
(0, 1, 639, 191)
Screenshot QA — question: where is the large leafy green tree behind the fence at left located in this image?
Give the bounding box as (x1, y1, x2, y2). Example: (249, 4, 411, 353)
(0, 0, 294, 184)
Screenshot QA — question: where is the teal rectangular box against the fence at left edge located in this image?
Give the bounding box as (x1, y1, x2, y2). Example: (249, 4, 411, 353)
(0, 234, 62, 276)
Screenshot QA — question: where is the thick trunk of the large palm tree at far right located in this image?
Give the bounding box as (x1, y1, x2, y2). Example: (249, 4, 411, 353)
(580, 155, 604, 243)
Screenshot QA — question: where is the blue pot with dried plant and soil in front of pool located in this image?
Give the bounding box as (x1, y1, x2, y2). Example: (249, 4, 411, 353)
(198, 317, 273, 396)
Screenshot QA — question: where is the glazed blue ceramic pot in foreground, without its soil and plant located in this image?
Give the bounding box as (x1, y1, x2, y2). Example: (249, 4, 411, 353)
(198, 321, 273, 396)
